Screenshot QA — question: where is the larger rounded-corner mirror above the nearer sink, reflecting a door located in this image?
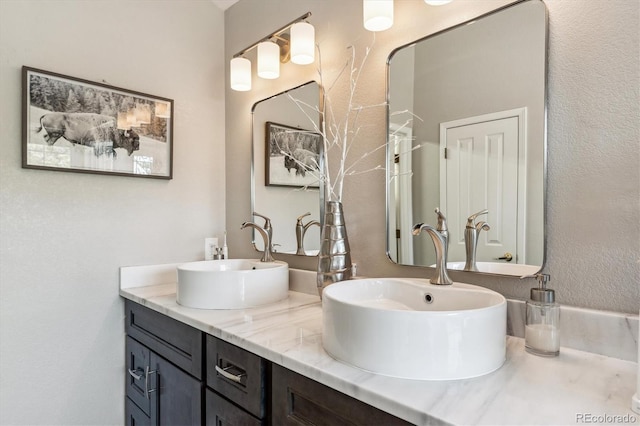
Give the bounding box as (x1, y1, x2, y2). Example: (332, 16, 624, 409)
(387, 0, 547, 275)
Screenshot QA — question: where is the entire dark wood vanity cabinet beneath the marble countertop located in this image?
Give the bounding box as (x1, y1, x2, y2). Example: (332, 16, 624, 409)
(125, 300, 409, 426)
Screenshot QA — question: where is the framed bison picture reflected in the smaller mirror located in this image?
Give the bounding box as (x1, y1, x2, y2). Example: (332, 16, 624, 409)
(265, 121, 322, 188)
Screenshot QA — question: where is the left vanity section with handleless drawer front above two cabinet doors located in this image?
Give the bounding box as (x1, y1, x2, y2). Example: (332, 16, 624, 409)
(125, 301, 204, 426)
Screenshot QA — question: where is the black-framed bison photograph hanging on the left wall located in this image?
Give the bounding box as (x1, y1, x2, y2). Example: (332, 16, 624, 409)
(22, 66, 173, 179)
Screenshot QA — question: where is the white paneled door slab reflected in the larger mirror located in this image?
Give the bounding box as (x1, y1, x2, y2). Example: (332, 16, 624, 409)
(444, 117, 519, 261)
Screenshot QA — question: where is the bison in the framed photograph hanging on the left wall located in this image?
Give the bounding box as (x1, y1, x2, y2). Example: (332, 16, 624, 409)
(36, 112, 140, 157)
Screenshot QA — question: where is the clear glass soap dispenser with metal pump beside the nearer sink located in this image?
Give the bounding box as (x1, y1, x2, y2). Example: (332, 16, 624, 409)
(524, 274, 560, 356)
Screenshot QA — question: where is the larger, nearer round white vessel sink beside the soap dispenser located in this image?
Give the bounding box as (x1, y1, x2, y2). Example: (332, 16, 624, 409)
(322, 278, 507, 380)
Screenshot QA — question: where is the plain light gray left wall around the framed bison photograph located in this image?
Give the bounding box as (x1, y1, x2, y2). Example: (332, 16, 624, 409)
(0, 0, 225, 425)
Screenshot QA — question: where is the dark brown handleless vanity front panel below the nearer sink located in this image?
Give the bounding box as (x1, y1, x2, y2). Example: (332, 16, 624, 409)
(271, 364, 411, 426)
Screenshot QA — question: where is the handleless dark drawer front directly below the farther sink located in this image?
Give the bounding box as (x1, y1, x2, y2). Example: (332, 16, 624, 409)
(125, 300, 204, 379)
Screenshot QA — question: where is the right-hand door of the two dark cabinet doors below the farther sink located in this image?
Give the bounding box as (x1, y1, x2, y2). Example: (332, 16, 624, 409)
(151, 352, 203, 425)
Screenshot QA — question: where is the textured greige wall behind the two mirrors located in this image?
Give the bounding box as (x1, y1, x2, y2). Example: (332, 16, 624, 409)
(225, 0, 640, 313)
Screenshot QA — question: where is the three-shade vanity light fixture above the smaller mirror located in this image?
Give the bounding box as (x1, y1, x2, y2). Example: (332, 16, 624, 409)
(229, 12, 315, 92)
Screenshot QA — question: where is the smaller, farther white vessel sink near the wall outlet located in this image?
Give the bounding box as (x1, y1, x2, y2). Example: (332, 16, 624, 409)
(176, 259, 289, 309)
